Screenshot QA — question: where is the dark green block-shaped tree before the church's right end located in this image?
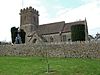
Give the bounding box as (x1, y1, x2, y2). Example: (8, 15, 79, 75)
(71, 24, 85, 41)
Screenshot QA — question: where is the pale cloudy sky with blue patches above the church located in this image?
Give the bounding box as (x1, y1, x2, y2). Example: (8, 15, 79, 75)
(0, 0, 100, 42)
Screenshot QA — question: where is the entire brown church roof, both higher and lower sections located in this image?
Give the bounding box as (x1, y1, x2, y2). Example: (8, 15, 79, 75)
(38, 20, 86, 35)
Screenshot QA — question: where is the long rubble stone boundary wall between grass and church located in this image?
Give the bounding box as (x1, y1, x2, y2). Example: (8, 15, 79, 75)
(0, 42, 100, 58)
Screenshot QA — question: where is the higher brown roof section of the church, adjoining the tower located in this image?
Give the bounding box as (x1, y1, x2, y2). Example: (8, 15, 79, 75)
(38, 21, 65, 34)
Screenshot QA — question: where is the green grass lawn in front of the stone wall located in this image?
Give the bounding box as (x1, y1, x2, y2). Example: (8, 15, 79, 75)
(0, 56, 100, 75)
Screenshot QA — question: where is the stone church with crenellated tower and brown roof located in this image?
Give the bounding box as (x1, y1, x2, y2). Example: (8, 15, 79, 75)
(20, 7, 88, 43)
